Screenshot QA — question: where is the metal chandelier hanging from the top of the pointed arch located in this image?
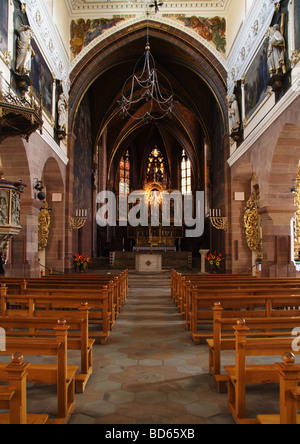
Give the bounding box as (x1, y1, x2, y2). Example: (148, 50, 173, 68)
(118, 12, 177, 123)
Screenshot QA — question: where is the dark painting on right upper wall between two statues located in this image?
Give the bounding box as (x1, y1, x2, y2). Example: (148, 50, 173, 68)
(245, 39, 270, 120)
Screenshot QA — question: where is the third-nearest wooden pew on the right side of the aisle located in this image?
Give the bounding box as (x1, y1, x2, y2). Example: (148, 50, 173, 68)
(207, 303, 300, 393)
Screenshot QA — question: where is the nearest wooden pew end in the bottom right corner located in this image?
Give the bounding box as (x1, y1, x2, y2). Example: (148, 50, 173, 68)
(257, 352, 300, 425)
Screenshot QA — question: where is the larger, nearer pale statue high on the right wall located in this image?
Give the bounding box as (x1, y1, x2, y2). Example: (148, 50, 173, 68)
(268, 25, 286, 75)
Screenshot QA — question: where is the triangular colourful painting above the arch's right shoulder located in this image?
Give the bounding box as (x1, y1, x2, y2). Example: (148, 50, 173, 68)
(179, 16, 226, 54)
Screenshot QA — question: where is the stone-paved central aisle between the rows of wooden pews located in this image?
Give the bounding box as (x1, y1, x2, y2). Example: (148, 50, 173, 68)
(70, 273, 232, 424)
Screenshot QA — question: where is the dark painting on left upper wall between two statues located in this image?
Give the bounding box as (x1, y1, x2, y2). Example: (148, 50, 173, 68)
(30, 41, 53, 116)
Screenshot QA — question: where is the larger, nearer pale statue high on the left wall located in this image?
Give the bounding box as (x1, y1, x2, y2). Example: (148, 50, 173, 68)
(16, 25, 35, 75)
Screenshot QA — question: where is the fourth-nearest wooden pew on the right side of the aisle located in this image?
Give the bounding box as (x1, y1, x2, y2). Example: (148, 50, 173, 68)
(191, 289, 300, 344)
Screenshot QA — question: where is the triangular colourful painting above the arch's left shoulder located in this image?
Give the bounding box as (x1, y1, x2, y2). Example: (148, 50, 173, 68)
(70, 18, 124, 57)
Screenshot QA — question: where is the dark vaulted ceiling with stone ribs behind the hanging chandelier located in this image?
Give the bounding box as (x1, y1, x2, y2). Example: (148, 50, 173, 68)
(70, 21, 227, 196)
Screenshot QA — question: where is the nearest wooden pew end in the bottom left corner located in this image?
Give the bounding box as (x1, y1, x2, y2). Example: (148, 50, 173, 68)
(0, 353, 48, 425)
